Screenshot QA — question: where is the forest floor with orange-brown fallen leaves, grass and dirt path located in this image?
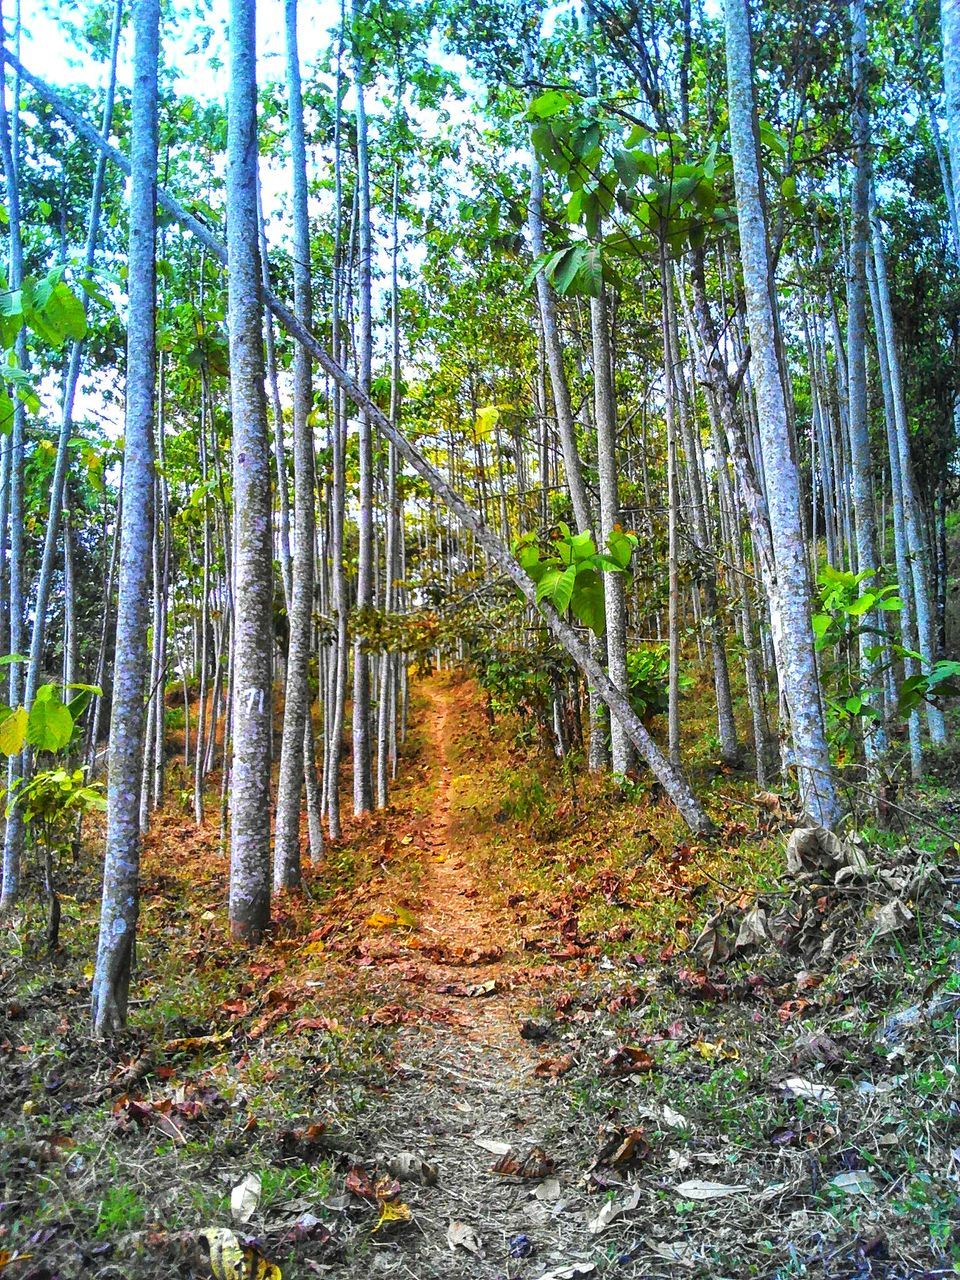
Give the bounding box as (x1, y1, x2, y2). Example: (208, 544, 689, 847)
(0, 676, 960, 1280)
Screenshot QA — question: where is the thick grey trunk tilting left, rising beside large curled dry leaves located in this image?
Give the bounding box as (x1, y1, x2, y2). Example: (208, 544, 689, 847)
(724, 0, 841, 827)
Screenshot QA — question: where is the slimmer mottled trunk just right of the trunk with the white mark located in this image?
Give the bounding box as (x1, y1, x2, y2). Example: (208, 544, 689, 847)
(274, 0, 316, 888)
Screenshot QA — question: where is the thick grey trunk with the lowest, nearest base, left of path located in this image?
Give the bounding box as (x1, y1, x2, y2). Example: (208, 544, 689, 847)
(92, 0, 160, 1036)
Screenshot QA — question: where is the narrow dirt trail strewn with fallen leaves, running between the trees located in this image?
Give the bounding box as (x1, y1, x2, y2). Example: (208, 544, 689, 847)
(338, 682, 601, 1280)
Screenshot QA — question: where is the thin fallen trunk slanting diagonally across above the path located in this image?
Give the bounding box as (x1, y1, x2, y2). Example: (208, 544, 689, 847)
(13, 49, 713, 835)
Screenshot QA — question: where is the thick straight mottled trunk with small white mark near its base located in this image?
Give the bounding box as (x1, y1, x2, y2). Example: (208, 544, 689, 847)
(227, 0, 273, 942)
